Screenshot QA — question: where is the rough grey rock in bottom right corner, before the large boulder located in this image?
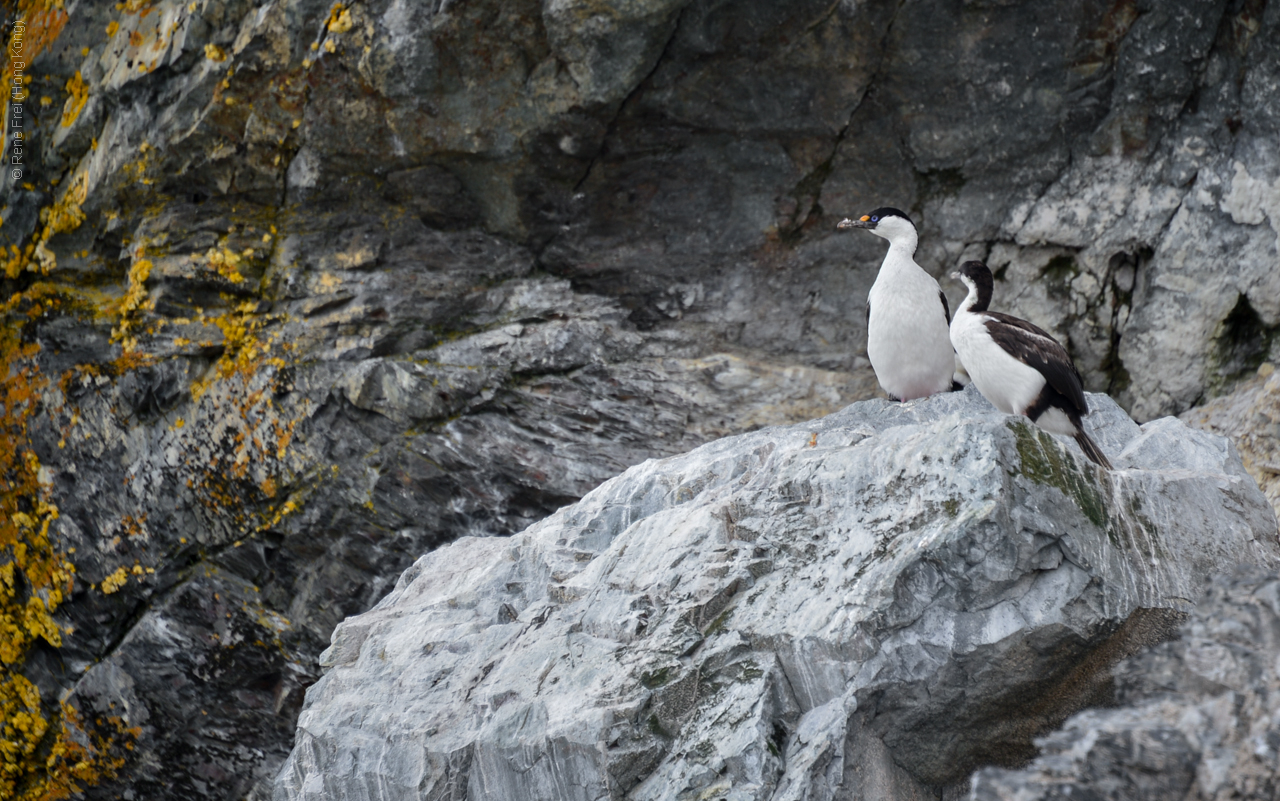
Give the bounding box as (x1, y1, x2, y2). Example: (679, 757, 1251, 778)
(965, 571, 1280, 801)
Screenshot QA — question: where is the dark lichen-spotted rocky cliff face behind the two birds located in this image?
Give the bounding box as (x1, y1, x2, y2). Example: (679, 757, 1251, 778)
(0, 0, 1280, 798)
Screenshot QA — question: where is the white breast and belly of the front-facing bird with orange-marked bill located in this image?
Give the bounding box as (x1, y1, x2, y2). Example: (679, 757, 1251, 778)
(867, 247, 955, 401)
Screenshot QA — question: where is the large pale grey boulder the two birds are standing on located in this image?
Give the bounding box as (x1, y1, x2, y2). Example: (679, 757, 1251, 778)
(274, 389, 1280, 801)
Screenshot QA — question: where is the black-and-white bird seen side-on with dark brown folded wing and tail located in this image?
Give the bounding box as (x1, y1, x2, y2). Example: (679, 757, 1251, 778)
(951, 255, 1111, 470)
